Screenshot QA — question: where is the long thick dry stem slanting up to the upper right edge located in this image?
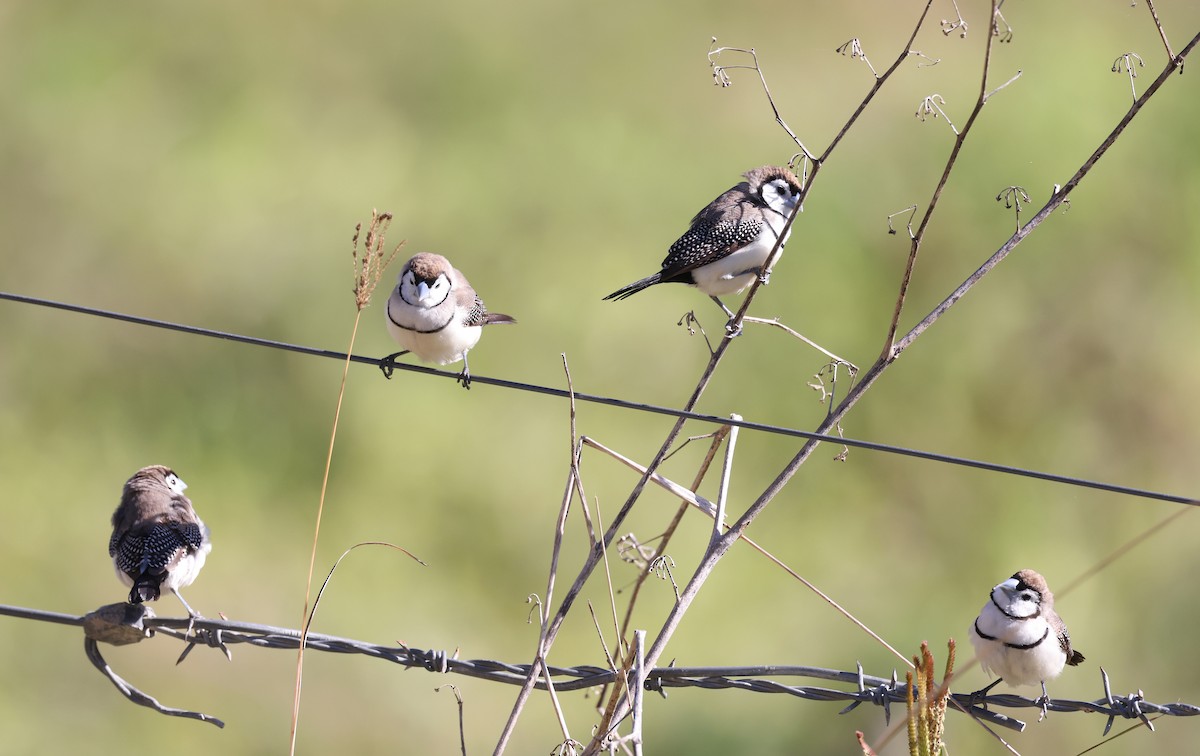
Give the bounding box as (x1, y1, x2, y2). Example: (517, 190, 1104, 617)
(589, 19, 1200, 752)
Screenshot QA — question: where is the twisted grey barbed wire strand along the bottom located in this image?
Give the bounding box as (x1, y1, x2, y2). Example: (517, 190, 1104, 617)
(0, 605, 1200, 733)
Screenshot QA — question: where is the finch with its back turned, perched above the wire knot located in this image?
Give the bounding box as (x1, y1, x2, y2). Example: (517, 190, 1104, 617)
(108, 464, 212, 619)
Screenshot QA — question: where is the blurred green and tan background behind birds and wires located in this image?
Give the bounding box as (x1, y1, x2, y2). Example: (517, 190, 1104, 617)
(0, 0, 1200, 754)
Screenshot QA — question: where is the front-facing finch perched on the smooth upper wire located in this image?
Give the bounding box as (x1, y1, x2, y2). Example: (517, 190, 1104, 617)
(379, 252, 516, 389)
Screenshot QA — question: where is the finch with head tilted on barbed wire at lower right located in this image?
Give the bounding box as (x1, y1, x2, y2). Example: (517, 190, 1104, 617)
(967, 570, 1084, 716)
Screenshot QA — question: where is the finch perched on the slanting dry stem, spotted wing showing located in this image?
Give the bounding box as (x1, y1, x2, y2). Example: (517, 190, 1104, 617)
(605, 166, 802, 326)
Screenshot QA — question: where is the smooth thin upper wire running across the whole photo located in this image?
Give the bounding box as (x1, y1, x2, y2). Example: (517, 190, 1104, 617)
(0, 292, 1200, 506)
